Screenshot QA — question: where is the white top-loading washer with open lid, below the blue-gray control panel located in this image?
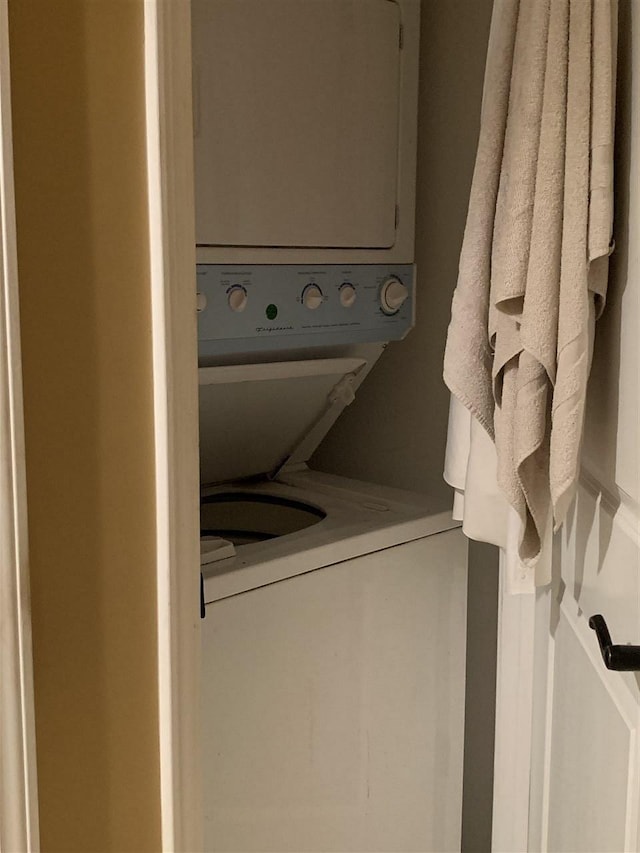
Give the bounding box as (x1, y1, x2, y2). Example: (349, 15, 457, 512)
(200, 345, 466, 853)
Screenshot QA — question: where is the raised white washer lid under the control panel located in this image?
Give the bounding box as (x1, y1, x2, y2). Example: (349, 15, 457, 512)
(198, 358, 367, 485)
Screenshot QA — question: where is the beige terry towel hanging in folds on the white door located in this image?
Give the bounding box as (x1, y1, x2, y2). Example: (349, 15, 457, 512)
(444, 0, 617, 580)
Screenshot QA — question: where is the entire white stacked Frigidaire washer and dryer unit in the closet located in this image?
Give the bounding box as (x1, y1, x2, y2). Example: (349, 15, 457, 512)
(192, 0, 466, 853)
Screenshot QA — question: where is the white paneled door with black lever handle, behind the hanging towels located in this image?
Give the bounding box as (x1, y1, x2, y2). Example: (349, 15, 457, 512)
(528, 4, 640, 853)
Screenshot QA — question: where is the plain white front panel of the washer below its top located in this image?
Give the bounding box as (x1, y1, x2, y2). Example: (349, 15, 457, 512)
(203, 530, 466, 853)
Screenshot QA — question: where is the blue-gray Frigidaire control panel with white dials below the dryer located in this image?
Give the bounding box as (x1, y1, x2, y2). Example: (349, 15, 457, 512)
(196, 264, 415, 357)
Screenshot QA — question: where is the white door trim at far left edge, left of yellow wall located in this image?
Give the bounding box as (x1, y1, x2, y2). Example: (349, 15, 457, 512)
(0, 0, 40, 853)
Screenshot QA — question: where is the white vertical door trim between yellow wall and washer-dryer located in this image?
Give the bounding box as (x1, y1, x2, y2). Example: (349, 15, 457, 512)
(144, 0, 203, 853)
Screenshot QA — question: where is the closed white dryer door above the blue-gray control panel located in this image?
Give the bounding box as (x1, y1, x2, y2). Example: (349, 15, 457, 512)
(192, 0, 400, 248)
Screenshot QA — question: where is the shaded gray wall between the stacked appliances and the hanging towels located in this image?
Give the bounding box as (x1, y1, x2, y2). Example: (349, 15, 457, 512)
(312, 0, 492, 508)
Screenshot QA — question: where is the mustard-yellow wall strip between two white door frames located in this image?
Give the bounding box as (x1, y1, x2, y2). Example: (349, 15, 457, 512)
(10, 0, 160, 853)
